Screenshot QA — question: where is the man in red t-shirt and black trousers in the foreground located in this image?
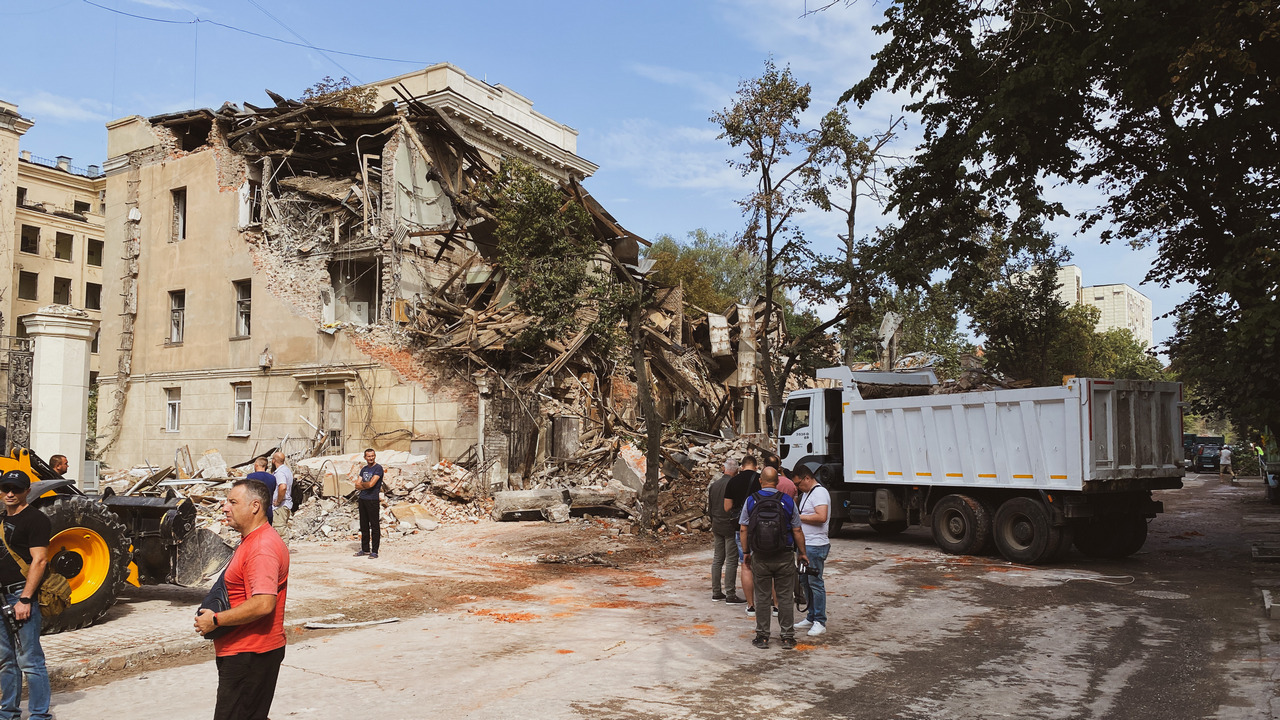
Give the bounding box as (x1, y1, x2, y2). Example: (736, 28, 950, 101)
(196, 478, 289, 720)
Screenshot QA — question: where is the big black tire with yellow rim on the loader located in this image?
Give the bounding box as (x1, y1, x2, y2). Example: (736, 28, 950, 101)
(40, 495, 131, 635)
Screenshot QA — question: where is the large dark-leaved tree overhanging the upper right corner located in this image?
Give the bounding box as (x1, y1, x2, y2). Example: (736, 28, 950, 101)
(846, 0, 1280, 427)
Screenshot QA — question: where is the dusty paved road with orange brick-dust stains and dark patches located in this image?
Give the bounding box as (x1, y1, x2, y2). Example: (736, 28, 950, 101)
(45, 475, 1280, 720)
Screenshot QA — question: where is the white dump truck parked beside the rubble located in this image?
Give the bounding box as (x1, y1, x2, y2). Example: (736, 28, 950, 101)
(778, 368, 1183, 564)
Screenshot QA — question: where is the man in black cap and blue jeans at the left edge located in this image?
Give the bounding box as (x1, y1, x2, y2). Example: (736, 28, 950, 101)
(0, 470, 52, 720)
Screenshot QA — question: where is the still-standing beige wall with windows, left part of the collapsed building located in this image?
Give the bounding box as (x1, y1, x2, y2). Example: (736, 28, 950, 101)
(100, 118, 477, 466)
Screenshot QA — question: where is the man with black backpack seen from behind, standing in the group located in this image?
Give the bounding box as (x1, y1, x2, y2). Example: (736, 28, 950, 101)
(739, 468, 809, 650)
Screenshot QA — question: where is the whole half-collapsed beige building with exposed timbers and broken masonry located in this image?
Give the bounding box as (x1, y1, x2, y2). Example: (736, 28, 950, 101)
(99, 64, 759, 491)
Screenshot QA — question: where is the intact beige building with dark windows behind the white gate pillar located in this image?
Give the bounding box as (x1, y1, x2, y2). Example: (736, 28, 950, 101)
(0, 101, 106, 378)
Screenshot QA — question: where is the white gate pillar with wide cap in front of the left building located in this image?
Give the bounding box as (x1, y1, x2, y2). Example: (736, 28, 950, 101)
(19, 305, 97, 482)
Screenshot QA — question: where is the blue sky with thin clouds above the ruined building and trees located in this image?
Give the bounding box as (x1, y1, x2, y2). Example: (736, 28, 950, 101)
(0, 0, 1187, 351)
